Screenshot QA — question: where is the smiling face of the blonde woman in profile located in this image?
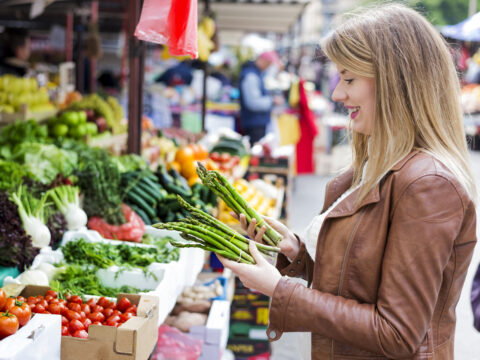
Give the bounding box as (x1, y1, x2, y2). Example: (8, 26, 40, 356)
(332, 66, 375, 135)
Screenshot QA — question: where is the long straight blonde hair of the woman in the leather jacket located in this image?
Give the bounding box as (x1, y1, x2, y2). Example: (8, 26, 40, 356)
(322, 4, 477, 201)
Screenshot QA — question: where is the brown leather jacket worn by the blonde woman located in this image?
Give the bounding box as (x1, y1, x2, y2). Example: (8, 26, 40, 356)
(267, 152, 476, 360)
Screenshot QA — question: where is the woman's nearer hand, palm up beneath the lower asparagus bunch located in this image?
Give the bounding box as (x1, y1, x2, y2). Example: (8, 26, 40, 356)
(217, 240, 282, 297)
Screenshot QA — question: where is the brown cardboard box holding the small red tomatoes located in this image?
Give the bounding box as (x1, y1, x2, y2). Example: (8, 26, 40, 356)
(20, 285, 159, 360)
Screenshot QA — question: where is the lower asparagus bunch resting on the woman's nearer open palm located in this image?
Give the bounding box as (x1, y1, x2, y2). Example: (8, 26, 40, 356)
(153, 196, 279, 264)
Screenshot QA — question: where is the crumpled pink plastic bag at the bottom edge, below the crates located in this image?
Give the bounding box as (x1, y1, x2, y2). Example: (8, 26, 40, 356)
(151, 325, 203, 360)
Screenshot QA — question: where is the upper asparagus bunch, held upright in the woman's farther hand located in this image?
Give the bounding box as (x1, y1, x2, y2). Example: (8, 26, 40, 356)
(197, 163, 282, 246)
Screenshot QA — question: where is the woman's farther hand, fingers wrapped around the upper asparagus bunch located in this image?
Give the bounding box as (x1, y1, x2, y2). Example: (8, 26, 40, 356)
(231, 212, 300, 259)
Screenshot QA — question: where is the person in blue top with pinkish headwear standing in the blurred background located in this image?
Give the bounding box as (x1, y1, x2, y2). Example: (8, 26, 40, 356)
(239, 51, 280, 145)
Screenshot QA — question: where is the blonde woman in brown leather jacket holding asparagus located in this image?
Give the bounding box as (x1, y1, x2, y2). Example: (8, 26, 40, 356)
(222, 5, 476, 360)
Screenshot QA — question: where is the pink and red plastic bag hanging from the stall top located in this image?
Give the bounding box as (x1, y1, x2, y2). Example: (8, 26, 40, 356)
(135, 0, 198, 59)
